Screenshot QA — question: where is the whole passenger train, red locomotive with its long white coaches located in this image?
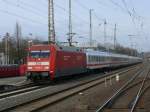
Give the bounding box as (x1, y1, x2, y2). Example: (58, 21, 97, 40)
(27, 44, 142, 80)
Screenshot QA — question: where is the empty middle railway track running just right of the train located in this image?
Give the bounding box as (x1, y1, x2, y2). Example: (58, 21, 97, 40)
(2, 63, 140, 112)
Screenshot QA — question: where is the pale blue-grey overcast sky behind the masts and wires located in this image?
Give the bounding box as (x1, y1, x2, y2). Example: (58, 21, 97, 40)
(0, 0, 150, 51)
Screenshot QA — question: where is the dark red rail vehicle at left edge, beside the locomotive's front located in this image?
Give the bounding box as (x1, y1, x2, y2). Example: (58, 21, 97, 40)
(0, 64, 26, 78)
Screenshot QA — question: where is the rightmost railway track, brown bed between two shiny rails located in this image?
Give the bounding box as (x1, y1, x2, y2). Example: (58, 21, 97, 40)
(96, 62, 150, 112)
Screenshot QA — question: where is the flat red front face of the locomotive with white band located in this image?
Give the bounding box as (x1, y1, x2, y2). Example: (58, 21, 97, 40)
(27, 45, 50, 78)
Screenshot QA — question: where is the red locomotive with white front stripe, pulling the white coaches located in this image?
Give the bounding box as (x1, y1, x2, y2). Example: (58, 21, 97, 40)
(27, 44, 86, 80)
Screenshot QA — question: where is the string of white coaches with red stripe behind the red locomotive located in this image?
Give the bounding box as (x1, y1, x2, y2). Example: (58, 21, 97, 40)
(85, 49, 142, 69)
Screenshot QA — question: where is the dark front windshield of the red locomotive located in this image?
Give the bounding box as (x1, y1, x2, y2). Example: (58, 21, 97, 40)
(30, 51, 50, 58)
